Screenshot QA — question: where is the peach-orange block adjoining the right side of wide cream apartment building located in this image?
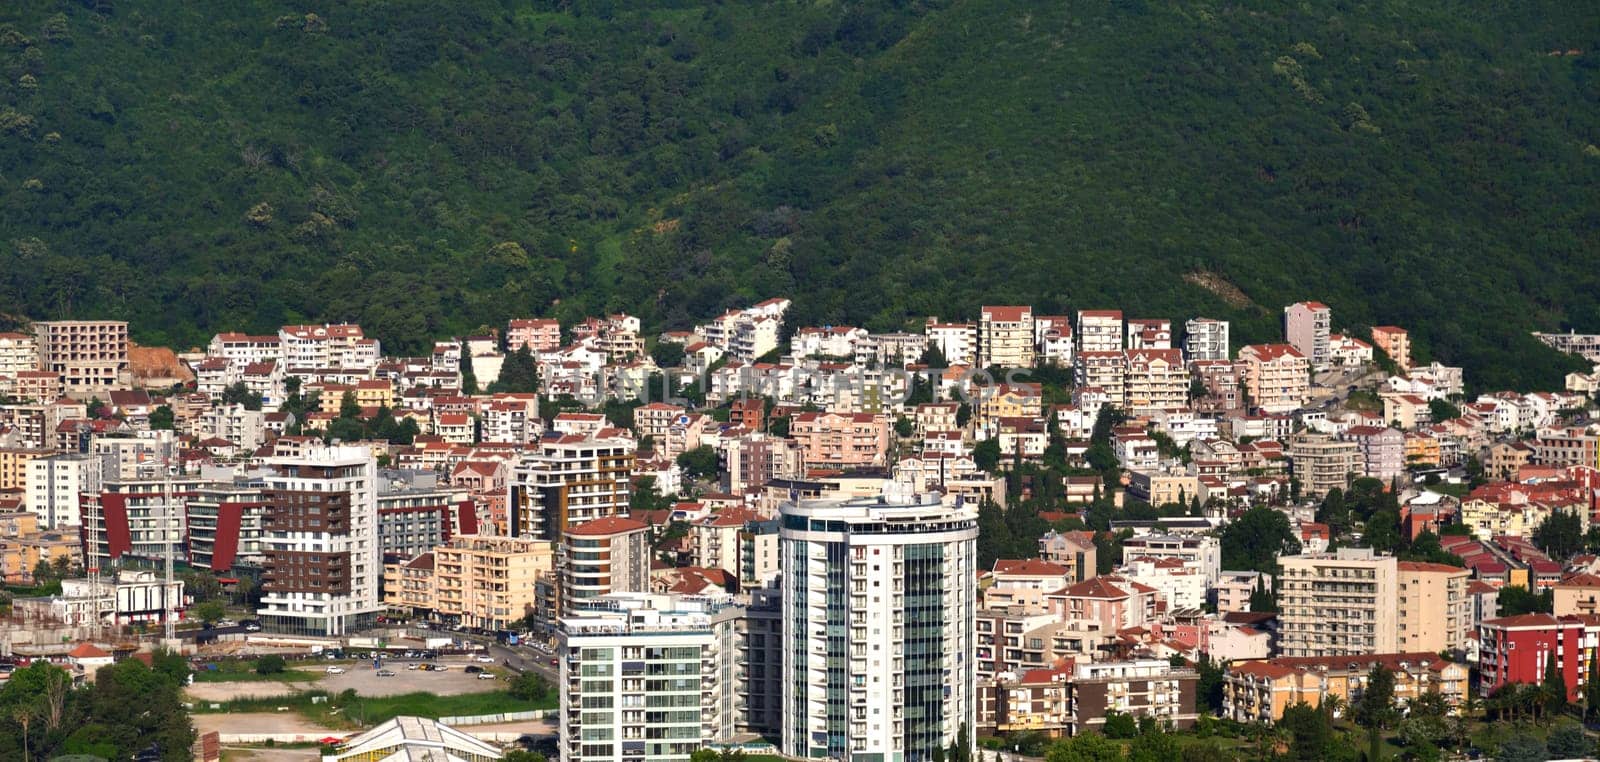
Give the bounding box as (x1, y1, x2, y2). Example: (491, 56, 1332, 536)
(1395, 560, 1472, 653)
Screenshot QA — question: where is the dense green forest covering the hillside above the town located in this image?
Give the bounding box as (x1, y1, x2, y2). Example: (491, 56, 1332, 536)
(0, 0, 1600, 387)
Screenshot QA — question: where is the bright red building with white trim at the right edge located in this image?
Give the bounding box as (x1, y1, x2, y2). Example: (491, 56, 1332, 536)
(1478, 613, 1600, 701)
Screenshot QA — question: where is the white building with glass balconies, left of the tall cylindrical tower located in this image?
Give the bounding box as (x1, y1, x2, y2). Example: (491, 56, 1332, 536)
(558, 594, 742, 762)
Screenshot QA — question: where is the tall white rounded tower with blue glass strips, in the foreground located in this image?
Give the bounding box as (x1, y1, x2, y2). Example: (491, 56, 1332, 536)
(781, 495, 978, 759)
